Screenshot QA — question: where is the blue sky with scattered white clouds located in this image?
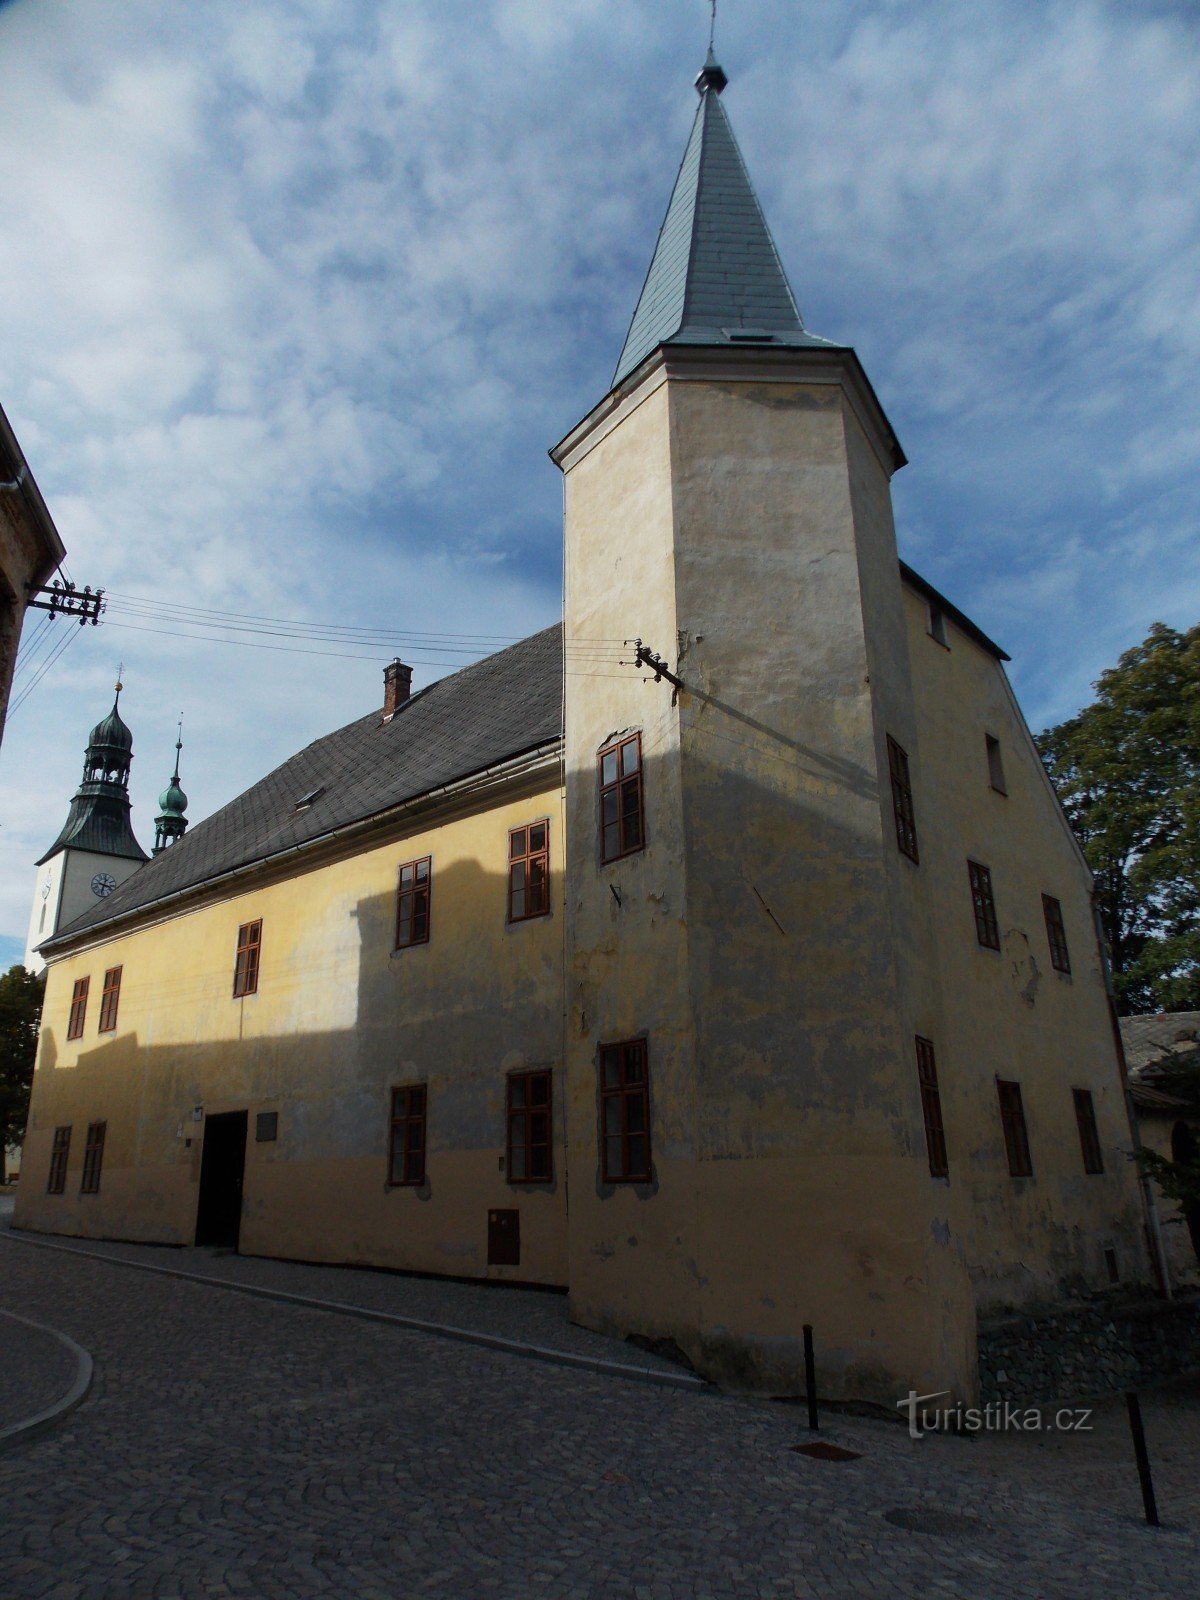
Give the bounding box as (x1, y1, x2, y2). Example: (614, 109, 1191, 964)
(0, 0, 1200, 965)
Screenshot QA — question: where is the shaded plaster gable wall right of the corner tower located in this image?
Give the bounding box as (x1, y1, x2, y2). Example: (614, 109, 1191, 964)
(904, 586, 1150, 1314)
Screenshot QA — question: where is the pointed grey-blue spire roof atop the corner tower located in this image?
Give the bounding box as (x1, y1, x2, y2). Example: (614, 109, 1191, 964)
(613, 62, 837, 386)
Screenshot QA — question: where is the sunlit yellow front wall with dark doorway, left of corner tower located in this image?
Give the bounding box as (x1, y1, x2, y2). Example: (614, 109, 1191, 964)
(14, 778, 566, 1283)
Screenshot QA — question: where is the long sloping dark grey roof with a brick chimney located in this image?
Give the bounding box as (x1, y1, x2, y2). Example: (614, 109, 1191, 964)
(42, 626, 563, 950)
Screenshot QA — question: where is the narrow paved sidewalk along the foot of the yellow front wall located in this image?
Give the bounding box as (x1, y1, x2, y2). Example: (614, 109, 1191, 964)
(0, 1206, 685, 1381)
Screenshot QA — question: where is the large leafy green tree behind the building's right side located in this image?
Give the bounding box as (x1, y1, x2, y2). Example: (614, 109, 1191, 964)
(1037, 622, 1200, 1013)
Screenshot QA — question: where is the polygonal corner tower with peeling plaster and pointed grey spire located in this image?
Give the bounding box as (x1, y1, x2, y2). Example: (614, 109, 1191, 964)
(550, 53, 974, 1398)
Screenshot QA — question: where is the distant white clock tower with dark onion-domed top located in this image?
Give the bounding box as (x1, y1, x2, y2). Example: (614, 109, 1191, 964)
(26, 683, 149, 973)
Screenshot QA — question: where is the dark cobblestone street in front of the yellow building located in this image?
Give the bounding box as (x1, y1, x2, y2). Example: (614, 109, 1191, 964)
(0, 1209, 1200, 1600)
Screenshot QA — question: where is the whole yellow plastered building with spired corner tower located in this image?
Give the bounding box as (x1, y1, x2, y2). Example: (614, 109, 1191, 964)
(16, 59, 1152, 1403)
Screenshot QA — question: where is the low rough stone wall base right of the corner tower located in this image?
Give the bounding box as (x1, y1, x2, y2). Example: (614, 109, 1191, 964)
(979, 1294, 1200, 1405)
